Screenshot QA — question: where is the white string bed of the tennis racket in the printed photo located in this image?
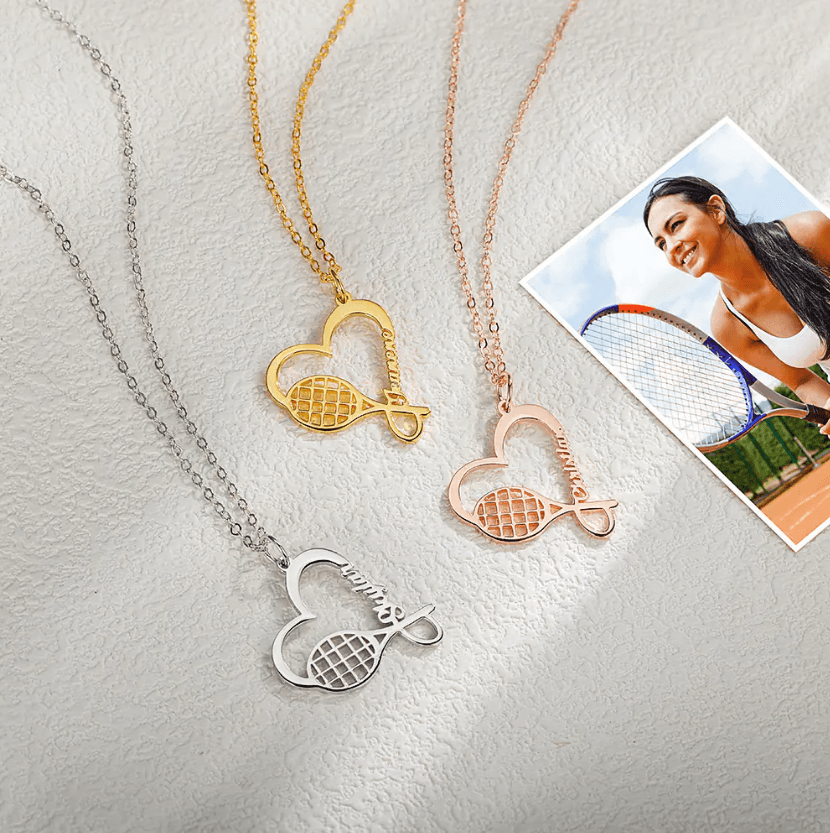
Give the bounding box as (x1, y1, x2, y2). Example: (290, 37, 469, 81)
(583, 312, 753, 445)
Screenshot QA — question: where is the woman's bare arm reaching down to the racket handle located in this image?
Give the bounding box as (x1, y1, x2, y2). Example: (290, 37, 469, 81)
(711, 306, 830, 435)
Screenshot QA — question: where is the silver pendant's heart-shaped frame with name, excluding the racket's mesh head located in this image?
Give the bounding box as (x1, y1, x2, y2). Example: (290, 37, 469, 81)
(271, 547, 444, 692)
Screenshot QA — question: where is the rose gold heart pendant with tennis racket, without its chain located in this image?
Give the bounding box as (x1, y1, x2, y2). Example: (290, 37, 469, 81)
(447, 405, 618, 544)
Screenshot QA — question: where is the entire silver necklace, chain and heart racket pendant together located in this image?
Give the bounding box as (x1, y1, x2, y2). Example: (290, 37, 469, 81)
(0, 0, 443, 691)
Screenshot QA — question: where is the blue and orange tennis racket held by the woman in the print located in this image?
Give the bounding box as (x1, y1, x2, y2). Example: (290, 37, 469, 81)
(580, 304, 830, 451)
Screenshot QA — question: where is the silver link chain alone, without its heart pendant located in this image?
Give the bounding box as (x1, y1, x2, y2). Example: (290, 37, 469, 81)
(0, 0, 289, 570)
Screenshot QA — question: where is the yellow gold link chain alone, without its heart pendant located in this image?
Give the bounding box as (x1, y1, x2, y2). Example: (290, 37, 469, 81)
(246, 0, 357, 304)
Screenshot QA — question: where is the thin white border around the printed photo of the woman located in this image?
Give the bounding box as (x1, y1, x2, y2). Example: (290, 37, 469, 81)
(521, 116, 830, 552)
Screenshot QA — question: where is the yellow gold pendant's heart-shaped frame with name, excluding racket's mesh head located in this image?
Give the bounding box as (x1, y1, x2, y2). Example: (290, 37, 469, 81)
(265, 298, 431, 443)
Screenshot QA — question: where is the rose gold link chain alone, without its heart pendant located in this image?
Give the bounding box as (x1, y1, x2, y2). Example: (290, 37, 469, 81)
(444, 0, 581, 413)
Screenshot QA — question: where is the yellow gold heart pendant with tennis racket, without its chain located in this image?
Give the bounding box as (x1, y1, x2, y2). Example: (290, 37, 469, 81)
(265, 298, 430, 443)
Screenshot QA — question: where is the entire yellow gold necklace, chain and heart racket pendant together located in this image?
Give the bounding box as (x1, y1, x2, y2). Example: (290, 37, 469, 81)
(246, 0, 430, 443)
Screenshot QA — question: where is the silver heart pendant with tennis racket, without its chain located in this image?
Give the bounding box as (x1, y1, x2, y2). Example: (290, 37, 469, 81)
(271, 549, 444, 691)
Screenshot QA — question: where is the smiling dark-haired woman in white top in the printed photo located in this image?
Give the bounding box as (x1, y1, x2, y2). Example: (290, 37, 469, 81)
(643, 176, 830, 434)
